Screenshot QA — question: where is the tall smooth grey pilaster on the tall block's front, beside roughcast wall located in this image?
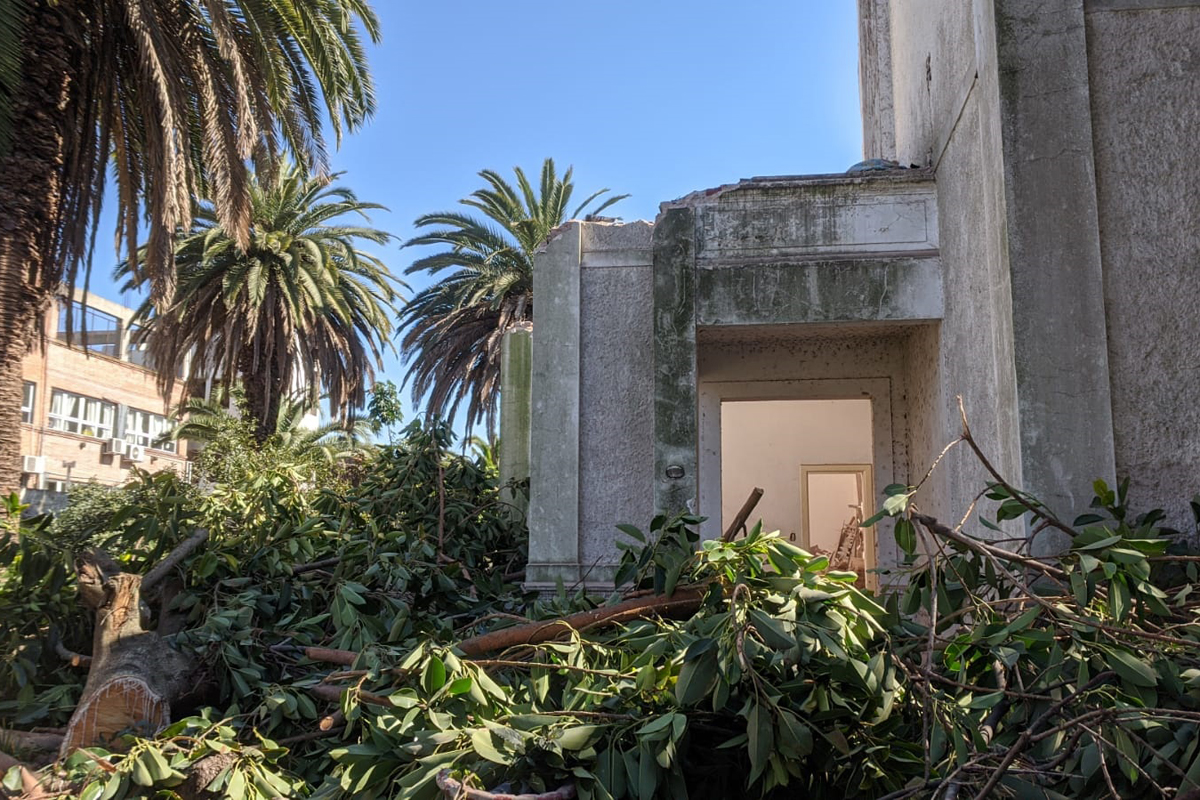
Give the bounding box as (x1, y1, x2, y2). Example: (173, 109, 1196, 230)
(994, 0, 1116, 532)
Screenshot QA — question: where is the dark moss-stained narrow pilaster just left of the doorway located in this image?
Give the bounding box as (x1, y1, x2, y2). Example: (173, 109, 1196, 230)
(654, 207, 700, 513)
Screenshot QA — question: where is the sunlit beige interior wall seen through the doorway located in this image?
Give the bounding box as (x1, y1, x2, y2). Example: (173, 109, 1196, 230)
(721, 399, 874, 541)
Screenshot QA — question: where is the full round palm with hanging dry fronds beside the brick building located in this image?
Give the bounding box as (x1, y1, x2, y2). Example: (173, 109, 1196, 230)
(118, 163, 396, 441)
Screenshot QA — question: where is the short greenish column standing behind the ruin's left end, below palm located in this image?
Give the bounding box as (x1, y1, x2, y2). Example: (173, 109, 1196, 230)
(500, 324, 533, 515)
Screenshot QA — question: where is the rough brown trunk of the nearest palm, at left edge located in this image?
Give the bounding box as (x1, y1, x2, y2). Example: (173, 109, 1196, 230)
(0, 2, 72, 494)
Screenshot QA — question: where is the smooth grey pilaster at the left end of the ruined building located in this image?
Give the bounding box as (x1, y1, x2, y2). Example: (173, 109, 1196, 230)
(526, 222, 581, 589)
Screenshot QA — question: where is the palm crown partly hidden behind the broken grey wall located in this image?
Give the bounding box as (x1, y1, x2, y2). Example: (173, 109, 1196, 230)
(400, 158, 629, 432)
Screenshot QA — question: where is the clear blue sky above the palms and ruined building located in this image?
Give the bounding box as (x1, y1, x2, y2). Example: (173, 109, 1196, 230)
(92, 0, 862, 422)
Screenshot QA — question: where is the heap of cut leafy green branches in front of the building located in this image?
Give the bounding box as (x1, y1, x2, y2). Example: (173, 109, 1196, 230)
(0, 412, 1200, 800)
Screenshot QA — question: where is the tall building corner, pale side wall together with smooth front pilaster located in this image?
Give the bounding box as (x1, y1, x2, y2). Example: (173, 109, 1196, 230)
(890, 0, 1114, 537)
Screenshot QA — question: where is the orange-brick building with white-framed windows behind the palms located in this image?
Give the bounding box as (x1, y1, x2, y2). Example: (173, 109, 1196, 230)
(20, 291, 187, 511)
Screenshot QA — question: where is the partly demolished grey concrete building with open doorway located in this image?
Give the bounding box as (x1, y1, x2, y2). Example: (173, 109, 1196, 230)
(528, 0, 1200, 588)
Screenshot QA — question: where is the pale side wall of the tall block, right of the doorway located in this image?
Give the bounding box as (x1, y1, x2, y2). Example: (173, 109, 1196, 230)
(890, 0, 1021, 527)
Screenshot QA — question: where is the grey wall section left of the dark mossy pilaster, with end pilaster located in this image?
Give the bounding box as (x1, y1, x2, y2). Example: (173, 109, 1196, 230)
(527, 222, 654, 589)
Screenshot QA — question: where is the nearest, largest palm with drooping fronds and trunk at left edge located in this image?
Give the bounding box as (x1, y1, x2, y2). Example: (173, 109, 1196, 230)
(0, 0, 379, 492)
